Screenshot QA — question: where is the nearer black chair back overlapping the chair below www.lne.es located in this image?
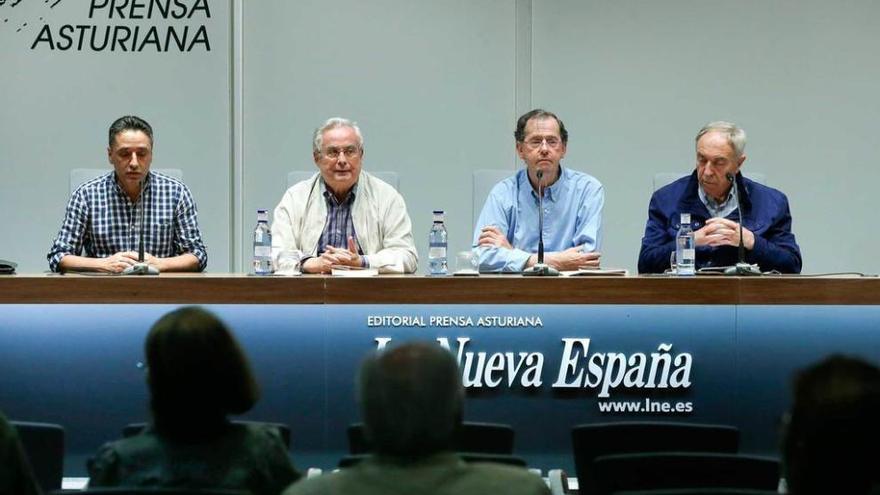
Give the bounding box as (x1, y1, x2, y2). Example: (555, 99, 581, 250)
(583, 452, 779, 495)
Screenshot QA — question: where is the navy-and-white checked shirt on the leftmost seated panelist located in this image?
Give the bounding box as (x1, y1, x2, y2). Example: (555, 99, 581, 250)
(46, 171, 208, 272)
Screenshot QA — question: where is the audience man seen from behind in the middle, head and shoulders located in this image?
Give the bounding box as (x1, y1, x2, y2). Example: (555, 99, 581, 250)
(284, 342, 550, 495)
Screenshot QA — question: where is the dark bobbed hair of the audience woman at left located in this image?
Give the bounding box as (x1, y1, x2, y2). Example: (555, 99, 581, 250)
(144, 306, 260, 436)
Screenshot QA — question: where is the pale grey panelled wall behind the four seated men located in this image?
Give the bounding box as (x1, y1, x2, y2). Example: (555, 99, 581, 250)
(0, 0, 880, 272)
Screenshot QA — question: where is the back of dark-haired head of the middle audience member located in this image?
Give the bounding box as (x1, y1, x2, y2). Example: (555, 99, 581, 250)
(359, 342, 464, 460)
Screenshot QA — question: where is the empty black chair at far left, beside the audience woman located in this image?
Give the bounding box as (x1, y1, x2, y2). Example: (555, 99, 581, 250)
(10, 421, 64, 492)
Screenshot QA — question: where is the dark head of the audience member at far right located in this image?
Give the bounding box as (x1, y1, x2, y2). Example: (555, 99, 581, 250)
(783, 355, 880, 495)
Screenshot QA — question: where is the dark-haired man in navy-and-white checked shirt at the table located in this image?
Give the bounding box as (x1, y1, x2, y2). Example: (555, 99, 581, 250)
(47, 116, 208, 273)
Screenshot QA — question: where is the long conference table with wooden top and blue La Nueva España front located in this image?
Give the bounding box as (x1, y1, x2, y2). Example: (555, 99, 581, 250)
(0, 273, 880, 476)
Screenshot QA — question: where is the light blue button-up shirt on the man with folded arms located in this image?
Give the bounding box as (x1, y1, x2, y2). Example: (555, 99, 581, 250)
(473, 167, 605, 272)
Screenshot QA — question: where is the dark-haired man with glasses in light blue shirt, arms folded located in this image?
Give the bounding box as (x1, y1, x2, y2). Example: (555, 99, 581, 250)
(474, 109, 605, 272)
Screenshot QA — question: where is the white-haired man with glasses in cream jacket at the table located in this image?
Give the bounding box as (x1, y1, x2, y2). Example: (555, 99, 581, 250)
(272, 118, 418, 273)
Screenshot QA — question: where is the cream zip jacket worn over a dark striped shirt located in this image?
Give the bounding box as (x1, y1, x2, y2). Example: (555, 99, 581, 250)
(272, 170, 419, 273)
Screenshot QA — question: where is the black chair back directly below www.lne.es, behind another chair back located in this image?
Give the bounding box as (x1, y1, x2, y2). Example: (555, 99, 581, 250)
(571, 421, 739, 493)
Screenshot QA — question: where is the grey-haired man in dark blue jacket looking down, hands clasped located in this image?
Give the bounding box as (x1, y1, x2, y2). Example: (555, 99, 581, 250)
(639, 121, 801, 273)
